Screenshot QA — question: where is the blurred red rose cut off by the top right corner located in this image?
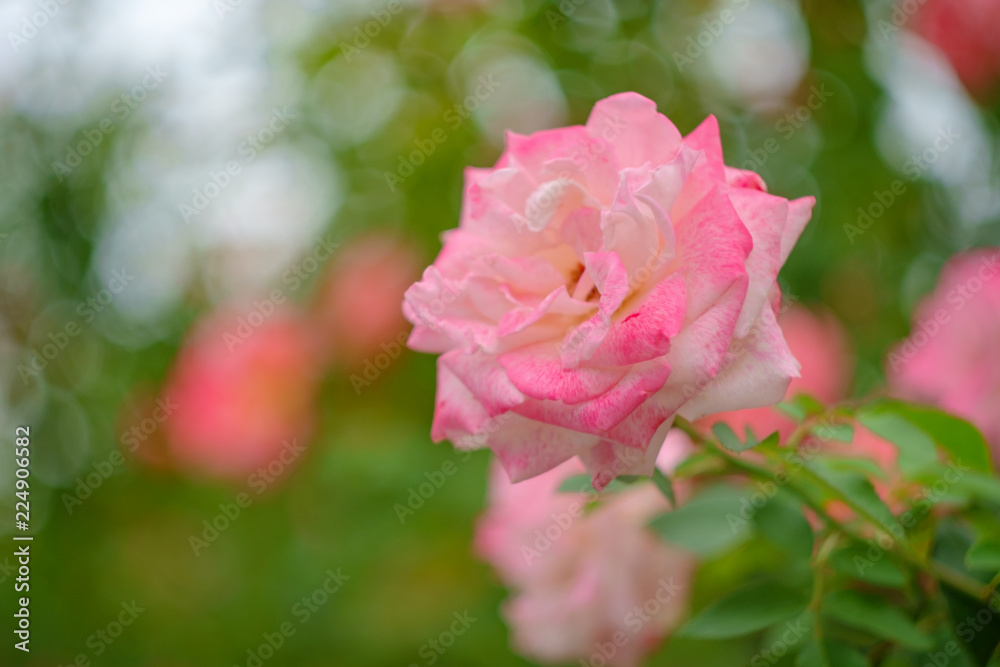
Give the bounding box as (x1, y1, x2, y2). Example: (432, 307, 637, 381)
(916, 0, 1000, 97)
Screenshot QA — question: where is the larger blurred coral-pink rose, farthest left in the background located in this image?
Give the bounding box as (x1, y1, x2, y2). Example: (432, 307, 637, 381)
(163, 310, 319, 480)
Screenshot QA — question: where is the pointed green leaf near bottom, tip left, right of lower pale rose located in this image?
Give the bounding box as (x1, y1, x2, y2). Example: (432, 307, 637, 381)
(680, 582, 809, 639)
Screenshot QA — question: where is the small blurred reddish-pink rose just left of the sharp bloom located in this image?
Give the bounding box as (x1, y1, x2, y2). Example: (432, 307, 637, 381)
(313, 234, 422, 367)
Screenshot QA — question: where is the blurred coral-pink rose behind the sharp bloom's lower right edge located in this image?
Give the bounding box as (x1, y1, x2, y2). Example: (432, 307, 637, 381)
(702, 306, 854, 439)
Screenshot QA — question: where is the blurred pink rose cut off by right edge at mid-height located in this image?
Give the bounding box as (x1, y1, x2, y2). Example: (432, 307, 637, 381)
(886, 248, 1000, 456)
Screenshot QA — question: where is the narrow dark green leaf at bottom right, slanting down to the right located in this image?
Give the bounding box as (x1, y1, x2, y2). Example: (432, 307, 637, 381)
(822, 591, 933, 651)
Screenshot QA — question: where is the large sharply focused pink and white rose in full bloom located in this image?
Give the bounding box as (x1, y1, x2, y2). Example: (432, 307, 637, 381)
(403, 93, 814, 488)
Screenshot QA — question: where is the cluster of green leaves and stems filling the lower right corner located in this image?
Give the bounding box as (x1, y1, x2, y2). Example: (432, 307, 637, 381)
(636, 397, 1000, 667)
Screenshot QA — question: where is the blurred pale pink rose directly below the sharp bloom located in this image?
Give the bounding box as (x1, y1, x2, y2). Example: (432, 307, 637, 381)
(476, 431, 694, 666)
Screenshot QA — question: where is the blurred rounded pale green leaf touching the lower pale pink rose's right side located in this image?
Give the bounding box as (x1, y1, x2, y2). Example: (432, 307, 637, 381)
(650, 485, 751, 557)
